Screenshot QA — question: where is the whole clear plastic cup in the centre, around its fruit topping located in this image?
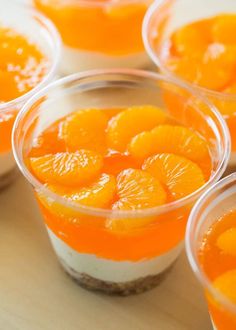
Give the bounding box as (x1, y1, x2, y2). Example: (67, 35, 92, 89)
(13, 69, 230, 295)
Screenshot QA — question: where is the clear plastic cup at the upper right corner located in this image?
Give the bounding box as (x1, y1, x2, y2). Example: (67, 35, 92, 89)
(142, 0, 236, 169)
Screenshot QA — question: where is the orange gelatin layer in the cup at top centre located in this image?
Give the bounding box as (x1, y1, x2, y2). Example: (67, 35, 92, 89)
(34, 0, 151, 55)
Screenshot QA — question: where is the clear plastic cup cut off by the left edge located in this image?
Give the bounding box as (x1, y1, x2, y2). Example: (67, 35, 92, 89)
(0, 2, 60, 189)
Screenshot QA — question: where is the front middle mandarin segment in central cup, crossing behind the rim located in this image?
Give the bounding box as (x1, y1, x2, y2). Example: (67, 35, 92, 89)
(107, 168, 167, 231)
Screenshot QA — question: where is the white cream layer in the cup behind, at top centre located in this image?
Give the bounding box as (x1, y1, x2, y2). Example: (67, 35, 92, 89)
(60, 46, 150, 74)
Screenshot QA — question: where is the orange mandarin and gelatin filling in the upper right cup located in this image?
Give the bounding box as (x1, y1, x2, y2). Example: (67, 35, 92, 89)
(156, 14, 236, 151)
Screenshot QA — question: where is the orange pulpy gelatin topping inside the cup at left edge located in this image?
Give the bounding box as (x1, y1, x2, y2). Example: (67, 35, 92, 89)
(0, 26, 48, 153)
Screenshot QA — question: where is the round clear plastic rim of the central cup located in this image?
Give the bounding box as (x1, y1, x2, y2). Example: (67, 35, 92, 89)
(12, 69, 231, 218)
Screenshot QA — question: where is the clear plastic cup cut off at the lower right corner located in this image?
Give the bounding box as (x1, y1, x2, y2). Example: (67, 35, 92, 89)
(186, 173, 236, 330)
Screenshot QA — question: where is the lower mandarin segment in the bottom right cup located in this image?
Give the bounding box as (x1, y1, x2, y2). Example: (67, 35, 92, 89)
(213, 270, 236, 304)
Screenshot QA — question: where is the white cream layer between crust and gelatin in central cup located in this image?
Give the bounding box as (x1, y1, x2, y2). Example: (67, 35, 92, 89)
(48, 229, 183, 283)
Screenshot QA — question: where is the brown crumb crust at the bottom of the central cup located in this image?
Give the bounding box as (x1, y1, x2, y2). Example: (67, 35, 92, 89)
(60, 259, 174, 296)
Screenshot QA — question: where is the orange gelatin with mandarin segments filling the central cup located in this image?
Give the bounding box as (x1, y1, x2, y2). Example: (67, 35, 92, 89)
(26, 105, 211, 260)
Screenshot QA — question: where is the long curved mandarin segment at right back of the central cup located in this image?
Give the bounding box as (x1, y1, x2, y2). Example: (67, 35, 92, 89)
(129, 125, 209, 163)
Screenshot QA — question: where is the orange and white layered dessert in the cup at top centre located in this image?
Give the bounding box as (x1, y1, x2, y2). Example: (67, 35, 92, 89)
(34, 0, 151, 74)
